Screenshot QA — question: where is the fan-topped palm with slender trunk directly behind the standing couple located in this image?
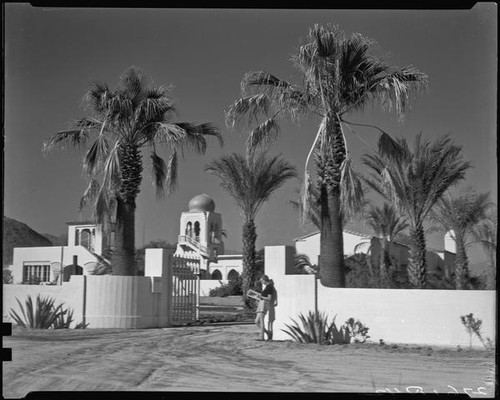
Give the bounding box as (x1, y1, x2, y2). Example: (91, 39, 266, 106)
(205, 153, 297, 302)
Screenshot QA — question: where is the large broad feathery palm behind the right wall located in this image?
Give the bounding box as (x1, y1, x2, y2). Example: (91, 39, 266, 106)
(363, 134, 470, 288)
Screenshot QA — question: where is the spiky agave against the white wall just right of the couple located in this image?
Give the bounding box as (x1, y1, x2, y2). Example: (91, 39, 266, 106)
(282, 311, 351, 344)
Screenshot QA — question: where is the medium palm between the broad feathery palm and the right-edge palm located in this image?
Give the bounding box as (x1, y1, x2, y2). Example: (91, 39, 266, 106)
(431, 192, 492, 290)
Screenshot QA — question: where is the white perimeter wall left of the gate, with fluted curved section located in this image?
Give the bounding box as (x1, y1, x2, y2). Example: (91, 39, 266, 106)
(2, 275, 170, 328)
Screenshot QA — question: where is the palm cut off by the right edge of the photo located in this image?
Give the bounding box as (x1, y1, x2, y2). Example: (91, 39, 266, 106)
(472, 207, 498, 290)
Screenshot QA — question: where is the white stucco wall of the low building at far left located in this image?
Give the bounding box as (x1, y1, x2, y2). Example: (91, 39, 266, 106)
(11, 246, 101, 283)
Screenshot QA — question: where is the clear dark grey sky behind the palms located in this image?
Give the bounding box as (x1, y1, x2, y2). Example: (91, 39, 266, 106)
(4, 3, 497, 262)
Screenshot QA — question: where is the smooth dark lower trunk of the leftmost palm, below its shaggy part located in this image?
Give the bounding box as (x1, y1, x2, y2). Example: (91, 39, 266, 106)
(111, 198, 136, 276)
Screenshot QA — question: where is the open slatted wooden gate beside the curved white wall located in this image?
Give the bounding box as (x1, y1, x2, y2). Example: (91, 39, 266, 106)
(170, 256, 200, 325)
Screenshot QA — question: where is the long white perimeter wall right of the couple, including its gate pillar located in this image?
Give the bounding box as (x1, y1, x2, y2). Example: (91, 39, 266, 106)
(265, 246, 496, 347)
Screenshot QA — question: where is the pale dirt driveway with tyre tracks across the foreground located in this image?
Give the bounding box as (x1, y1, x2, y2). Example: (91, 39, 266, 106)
(3, 324, 495, 398)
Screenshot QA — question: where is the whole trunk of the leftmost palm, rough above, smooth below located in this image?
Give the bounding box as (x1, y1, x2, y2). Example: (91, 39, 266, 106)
(111, 143, 142, 276)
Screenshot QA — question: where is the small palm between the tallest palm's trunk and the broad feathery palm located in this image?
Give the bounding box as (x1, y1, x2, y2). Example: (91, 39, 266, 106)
(365, 203, 408, 286)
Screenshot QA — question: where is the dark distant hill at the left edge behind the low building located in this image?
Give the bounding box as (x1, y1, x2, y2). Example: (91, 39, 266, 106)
(2, 216, 53, 265)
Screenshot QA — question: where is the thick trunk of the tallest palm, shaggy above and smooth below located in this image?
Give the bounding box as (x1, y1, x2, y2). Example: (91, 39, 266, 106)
(316, 118, 346, 287)
